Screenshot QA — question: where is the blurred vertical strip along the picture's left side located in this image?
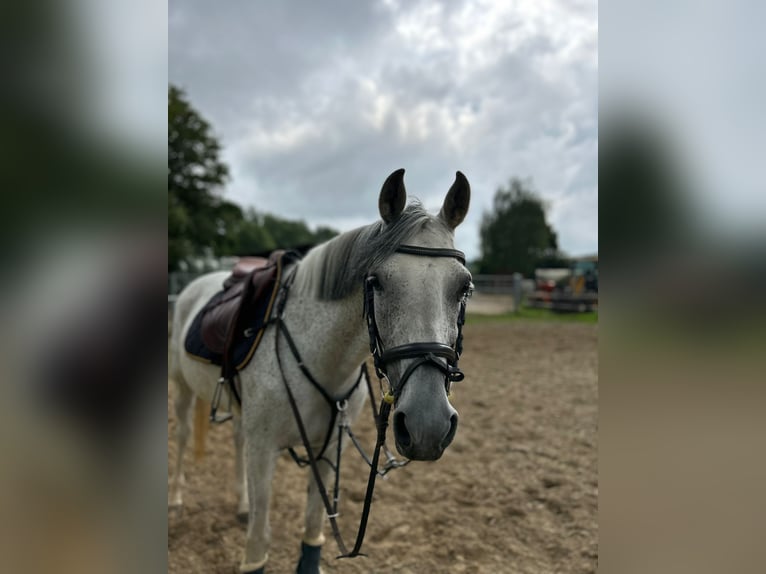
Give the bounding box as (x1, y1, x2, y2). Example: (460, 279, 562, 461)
(0, 0, 167, 573)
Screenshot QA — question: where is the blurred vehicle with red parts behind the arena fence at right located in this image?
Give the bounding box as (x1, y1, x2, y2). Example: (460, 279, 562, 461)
(527, 255, 598, 313)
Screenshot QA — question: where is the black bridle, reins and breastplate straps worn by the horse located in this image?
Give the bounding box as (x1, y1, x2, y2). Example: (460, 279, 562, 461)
(271, 245, 466, 558)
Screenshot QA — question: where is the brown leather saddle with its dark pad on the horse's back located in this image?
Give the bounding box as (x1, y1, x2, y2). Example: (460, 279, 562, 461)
(185, 250, 297, 378)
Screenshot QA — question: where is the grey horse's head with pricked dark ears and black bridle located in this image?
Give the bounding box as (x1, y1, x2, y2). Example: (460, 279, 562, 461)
(367, 170, 472, 460)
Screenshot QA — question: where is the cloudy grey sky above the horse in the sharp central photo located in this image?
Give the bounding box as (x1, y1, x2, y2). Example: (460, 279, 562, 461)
(169, 0, 598, 258)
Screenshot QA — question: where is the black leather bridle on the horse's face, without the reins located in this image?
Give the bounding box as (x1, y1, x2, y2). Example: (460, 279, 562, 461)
(364, 245, 466, 403)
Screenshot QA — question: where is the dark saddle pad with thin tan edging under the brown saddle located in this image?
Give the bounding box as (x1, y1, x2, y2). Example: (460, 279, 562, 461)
(184, 253, 291, 371)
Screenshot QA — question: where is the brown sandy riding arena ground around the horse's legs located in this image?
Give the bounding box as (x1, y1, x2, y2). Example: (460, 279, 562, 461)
(168, 322, 598, 574)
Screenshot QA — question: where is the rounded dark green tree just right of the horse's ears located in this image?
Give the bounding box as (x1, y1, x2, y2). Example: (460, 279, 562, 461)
(478, 178, 561, 277)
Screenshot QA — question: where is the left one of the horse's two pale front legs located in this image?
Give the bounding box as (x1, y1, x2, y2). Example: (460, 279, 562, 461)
(240, 448, 279, 574)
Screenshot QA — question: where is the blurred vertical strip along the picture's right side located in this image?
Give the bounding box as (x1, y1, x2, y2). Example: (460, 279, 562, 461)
(599, 1, 766, 572)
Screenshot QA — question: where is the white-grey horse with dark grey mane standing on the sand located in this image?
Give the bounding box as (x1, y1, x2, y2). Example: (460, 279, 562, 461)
(169, 169, 472, 574)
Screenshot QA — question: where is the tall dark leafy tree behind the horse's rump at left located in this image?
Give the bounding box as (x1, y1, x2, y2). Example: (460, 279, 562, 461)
(168, 86, 230, 269)
